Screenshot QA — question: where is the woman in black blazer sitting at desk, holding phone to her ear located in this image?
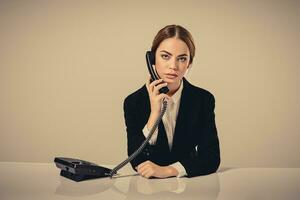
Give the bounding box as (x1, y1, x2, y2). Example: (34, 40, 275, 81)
(124, 25, 220, 178)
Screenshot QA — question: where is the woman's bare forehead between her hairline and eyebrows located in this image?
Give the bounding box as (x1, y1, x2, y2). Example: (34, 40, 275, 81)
(157, 38, 190, 55)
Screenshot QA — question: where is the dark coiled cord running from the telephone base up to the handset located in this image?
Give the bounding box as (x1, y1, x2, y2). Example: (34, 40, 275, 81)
(109, 100, 168, 178)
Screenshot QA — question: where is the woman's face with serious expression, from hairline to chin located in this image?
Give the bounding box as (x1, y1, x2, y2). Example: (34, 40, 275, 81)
(155, 38, 190, 85)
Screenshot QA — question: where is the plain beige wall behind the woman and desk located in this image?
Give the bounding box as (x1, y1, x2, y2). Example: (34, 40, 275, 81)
(0, 0, 300, 167)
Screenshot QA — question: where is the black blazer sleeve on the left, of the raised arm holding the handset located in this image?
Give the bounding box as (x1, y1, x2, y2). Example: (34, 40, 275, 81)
(123, 98, 153, 170)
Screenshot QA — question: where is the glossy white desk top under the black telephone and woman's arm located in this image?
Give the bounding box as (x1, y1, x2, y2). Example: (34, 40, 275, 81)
(0, 162, 300, 200)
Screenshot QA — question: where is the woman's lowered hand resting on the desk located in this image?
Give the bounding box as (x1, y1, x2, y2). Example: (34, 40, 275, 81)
(136, 160, 178, 178)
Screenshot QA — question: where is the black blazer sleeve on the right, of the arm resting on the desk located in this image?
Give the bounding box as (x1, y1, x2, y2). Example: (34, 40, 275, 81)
(179, 93, 220, 177)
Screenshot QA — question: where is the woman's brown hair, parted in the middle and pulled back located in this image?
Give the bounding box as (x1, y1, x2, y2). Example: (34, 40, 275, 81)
(151, 25, 195, 64)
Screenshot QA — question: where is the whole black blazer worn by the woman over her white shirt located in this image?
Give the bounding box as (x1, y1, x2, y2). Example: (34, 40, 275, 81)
(124, 78, 220, 177)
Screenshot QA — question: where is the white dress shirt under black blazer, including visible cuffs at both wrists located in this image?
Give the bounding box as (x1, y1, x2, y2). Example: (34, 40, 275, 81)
(143, 81, 187, 177)
